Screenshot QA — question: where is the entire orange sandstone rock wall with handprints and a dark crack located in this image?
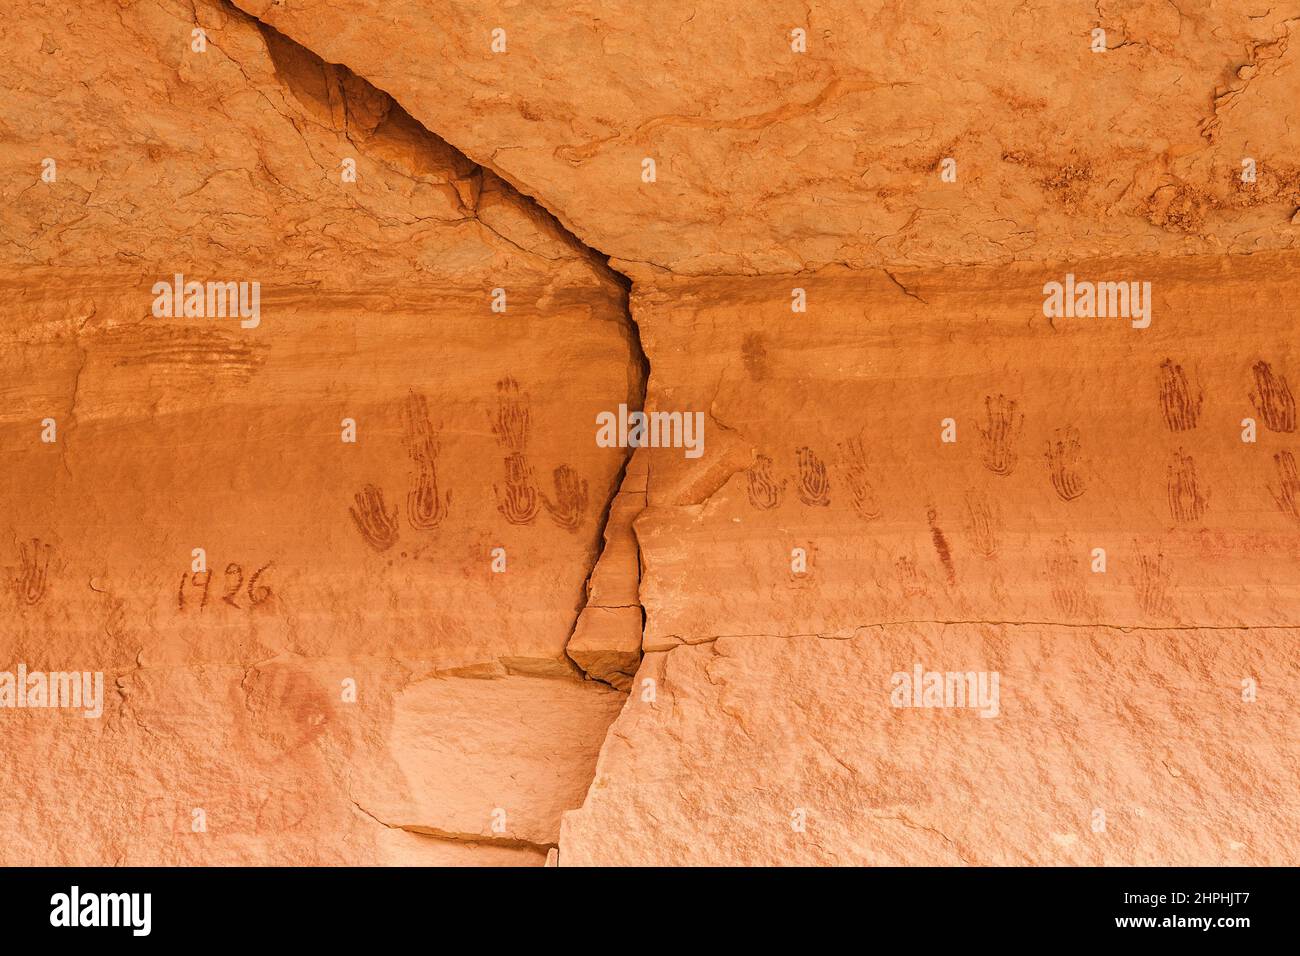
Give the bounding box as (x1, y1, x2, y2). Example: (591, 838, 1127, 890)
(0, 0, 1300, 865)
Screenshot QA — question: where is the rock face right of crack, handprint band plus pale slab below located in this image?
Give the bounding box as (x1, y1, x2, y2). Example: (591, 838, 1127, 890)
(560, 256, 1300, 865)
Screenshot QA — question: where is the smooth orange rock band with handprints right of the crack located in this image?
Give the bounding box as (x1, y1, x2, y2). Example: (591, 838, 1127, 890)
(634, 256, 1300, 650)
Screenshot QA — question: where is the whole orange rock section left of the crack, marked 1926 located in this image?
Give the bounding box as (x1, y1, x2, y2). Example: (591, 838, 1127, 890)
(0, 3, 642, 864)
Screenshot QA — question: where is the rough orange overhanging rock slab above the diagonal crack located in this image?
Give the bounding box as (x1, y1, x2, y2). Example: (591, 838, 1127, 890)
(228, 0, 1300, 274)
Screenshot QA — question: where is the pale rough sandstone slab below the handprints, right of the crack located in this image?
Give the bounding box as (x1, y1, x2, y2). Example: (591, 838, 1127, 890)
(560, 629, 1300, 866)
